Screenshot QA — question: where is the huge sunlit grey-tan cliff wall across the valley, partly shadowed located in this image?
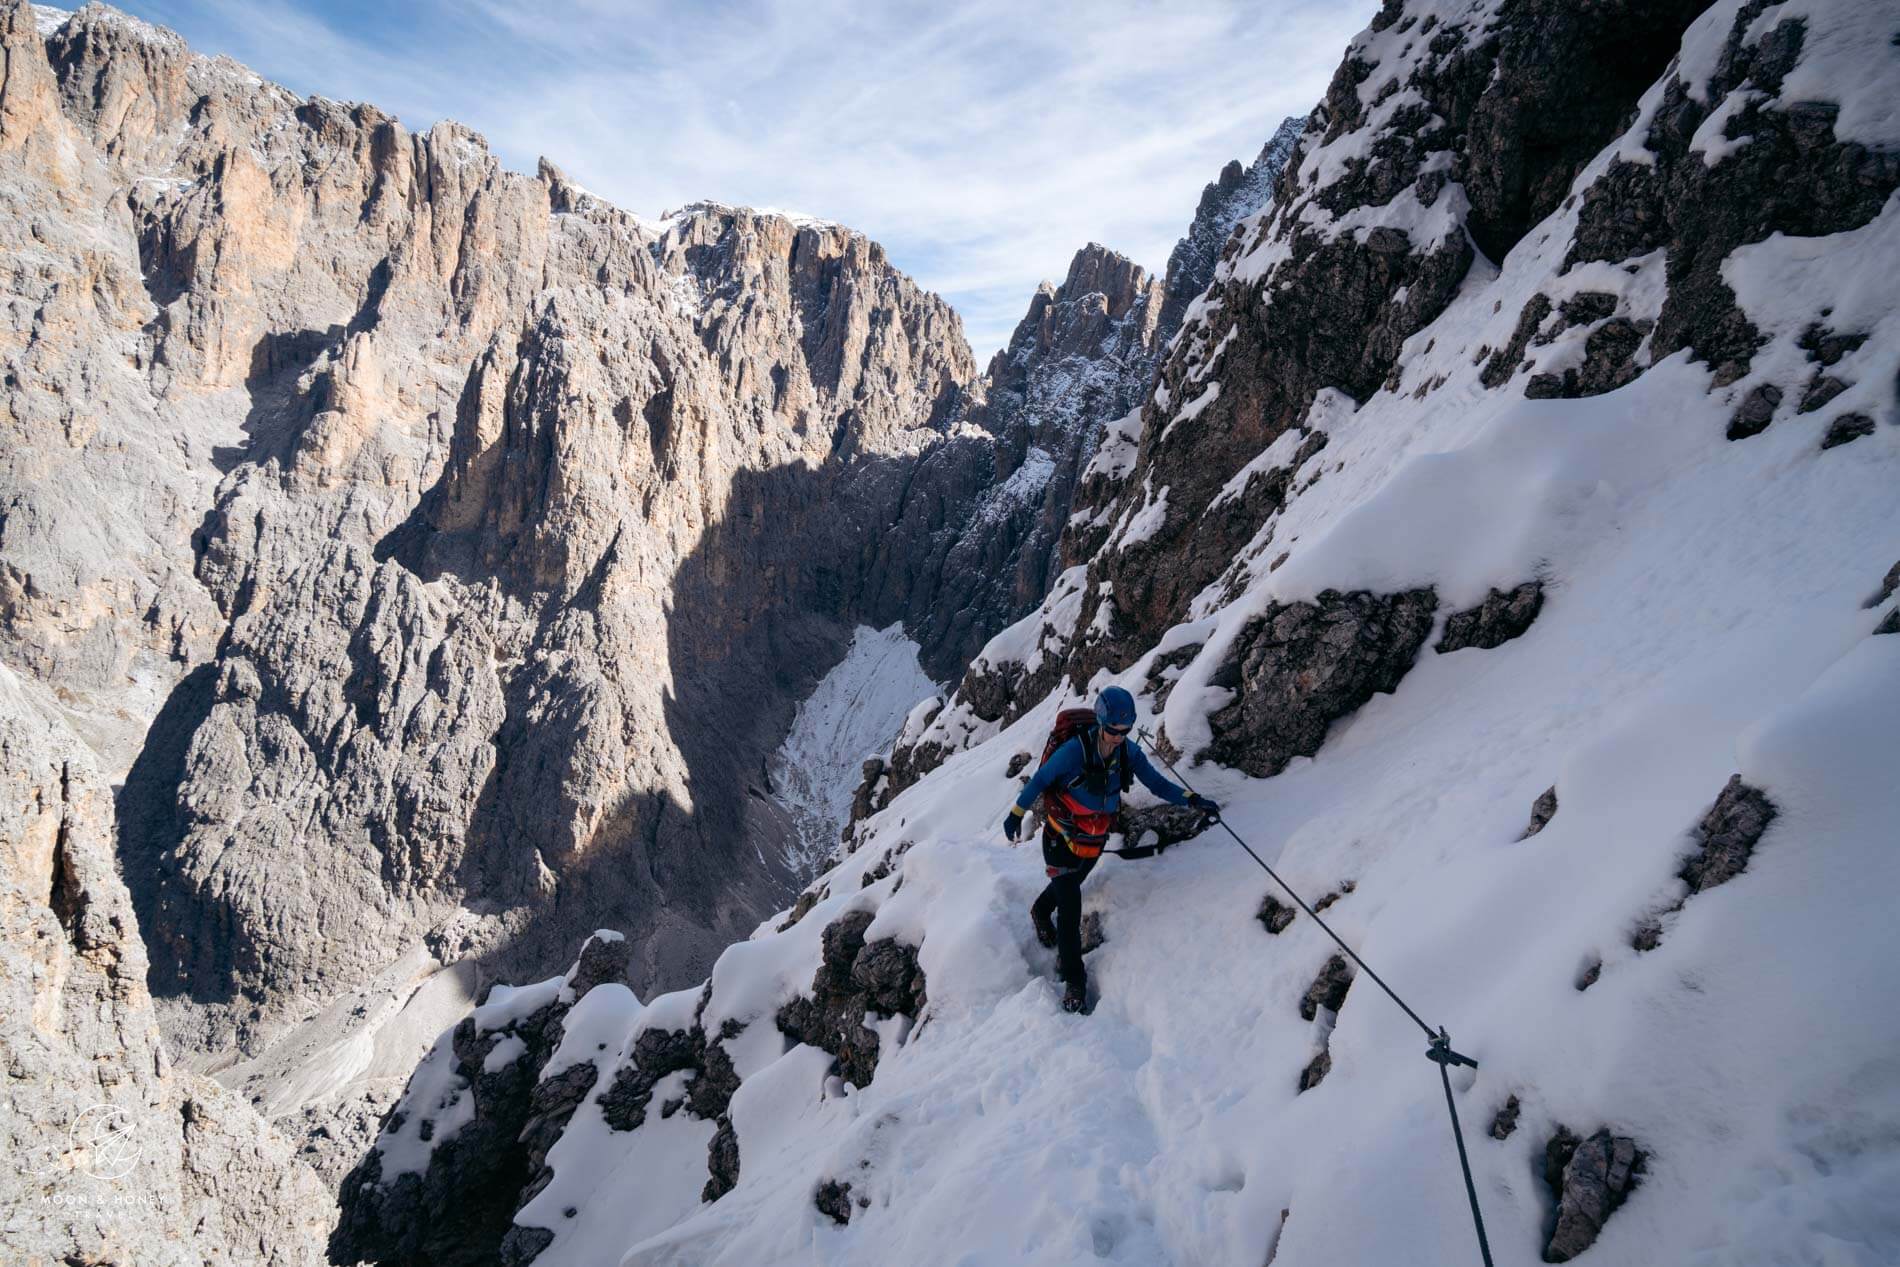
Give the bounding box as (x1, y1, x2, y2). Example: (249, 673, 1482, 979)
(4, 8, 986, 1071)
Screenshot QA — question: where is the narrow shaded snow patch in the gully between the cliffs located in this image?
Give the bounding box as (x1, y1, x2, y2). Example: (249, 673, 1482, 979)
(770, 625, 937, 878)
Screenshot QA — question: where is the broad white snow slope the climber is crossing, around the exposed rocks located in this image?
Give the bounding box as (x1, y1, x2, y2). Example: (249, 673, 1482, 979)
(592, 341, 1900, 1267)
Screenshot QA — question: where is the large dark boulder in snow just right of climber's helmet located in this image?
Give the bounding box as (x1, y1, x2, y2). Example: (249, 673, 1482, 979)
(1205, 589, 1438, 777)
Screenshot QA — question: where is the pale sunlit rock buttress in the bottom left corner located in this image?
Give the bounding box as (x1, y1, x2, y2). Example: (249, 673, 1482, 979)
(0, 669, 333, 1267)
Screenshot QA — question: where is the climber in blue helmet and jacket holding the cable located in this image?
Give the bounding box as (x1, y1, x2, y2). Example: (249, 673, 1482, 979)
(1003, 686, 1220, 1012)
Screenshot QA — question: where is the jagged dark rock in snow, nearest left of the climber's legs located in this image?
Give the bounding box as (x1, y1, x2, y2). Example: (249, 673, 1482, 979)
(775, 910, 925, 1087)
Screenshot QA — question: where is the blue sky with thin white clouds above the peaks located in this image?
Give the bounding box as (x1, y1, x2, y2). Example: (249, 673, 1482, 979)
(118, 0, 1378, 357)
